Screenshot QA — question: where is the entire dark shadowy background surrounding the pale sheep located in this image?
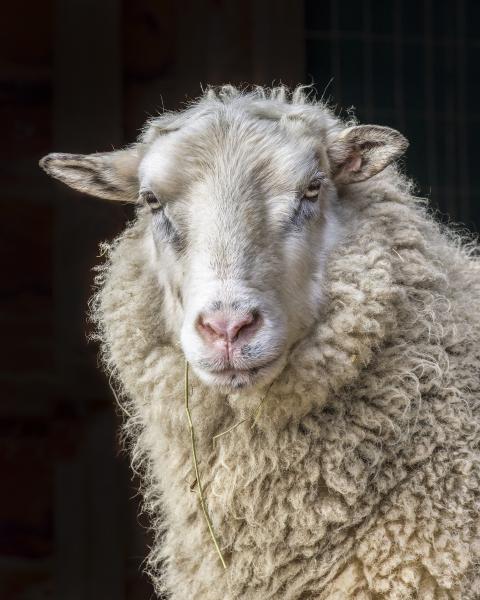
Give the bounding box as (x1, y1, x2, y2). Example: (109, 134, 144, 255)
(0, 0, 480, 600)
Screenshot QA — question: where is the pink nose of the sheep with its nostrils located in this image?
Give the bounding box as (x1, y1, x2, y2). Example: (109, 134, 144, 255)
(197, 311, 260, 343)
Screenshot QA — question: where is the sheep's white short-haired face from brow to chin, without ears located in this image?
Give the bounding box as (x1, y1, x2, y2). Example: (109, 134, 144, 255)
(140, 117, 339, 388)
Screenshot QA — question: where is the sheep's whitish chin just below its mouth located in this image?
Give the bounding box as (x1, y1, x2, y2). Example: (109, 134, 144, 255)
(192, 355, 285, 393)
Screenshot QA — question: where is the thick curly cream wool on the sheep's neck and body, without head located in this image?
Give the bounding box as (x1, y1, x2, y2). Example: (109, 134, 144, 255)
(93, 91, 480, 600)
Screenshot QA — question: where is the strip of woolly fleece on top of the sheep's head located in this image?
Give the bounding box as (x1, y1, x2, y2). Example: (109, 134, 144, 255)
(141, 86, 344, 144)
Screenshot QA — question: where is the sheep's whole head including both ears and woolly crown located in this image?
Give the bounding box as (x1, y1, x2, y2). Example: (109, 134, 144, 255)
(41, 88, 407, 389)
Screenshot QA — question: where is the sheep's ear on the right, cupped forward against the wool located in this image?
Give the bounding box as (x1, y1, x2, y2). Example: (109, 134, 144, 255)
(327, 125, 408, 184)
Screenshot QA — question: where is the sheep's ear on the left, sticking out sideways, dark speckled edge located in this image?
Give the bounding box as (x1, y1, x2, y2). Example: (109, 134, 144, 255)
(40, 146, 140, 202)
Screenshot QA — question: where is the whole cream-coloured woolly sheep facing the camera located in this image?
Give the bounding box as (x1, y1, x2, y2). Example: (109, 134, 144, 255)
(41, 86, 480, 600)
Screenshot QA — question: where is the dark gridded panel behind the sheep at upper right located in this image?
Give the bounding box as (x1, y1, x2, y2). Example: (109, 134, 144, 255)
(305, 0, 480, 230)
